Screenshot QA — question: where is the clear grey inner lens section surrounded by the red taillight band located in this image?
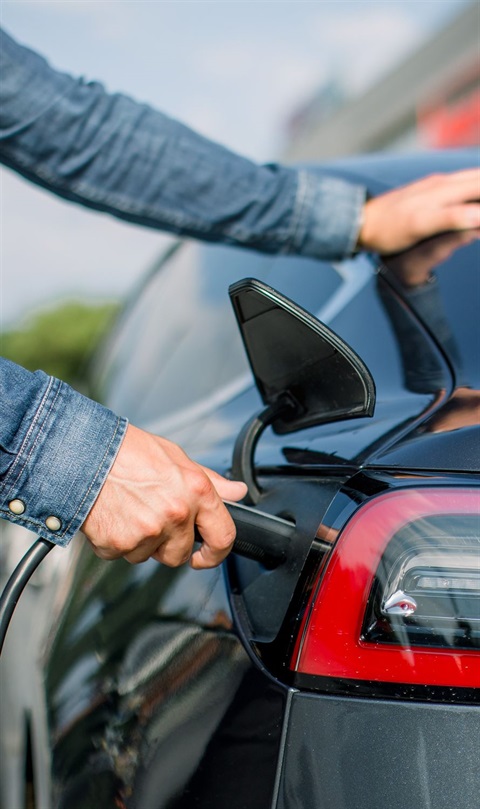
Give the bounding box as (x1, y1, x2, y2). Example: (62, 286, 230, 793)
(362, 514, 480, 649)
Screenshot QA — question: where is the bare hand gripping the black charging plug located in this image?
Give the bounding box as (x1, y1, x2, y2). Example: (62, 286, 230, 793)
(82, 425, 247, 568)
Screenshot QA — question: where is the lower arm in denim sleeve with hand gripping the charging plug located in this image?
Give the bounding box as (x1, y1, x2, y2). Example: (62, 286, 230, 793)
(0, 359, 246, 568)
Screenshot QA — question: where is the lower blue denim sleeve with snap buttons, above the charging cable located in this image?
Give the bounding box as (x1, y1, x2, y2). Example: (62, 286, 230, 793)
(0, 359, 127, 545)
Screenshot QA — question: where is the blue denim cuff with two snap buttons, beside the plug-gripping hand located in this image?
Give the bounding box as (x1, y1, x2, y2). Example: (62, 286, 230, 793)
(0, 377, 127, 546)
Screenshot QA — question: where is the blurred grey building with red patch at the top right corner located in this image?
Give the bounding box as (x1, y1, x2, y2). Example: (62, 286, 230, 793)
(282, 0, 480, 161)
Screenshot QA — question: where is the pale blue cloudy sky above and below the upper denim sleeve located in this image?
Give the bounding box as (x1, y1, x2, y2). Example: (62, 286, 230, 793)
(0, 0, 469, 330)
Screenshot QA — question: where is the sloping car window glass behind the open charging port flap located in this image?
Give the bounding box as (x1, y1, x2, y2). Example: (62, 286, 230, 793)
(95, 242, 342, 426)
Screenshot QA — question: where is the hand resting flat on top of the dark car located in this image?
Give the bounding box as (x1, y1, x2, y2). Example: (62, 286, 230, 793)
(358, 169, 480, 255)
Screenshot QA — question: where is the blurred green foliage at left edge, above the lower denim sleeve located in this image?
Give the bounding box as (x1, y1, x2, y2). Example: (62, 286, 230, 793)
(0, 302, 119, 385)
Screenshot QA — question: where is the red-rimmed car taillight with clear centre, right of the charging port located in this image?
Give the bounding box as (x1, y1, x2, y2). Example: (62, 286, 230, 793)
(293, 488, 480, 688)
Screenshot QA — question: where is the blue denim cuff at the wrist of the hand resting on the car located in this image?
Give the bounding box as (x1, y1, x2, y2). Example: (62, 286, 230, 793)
(293, 171, 366, 259)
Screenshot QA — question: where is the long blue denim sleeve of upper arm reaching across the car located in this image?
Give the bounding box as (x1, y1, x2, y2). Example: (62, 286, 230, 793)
(0, 27, 364, 258)
